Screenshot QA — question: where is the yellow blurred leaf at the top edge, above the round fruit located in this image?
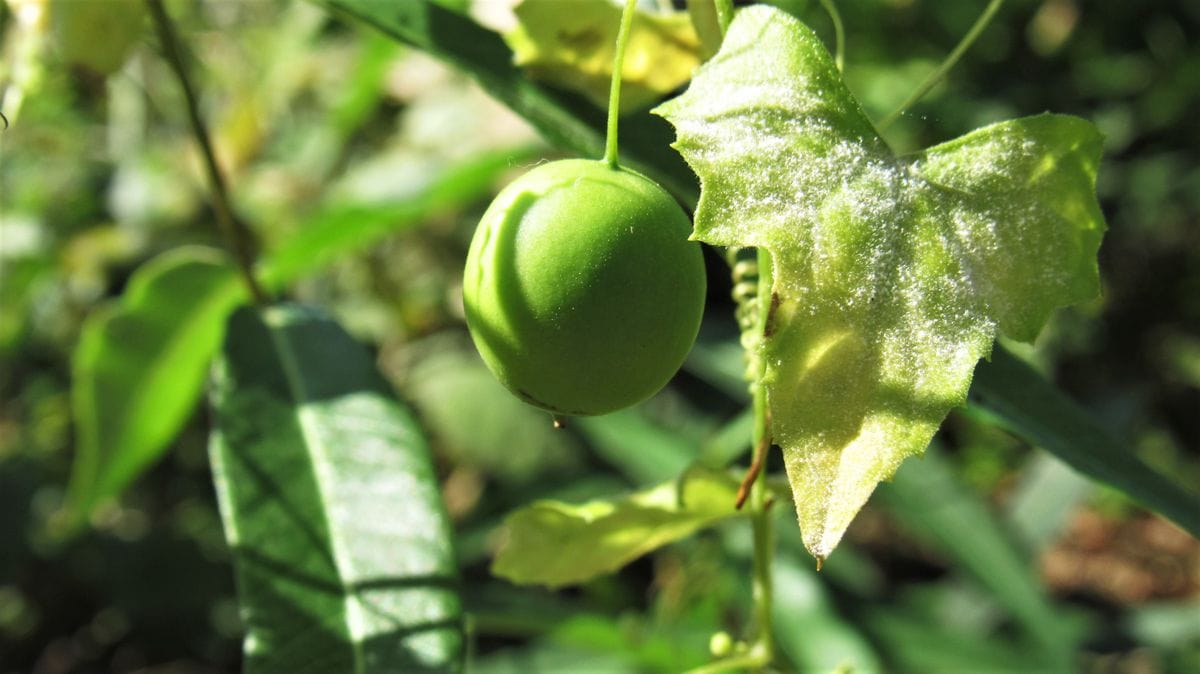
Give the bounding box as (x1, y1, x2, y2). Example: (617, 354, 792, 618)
(504, 0, 700, 115)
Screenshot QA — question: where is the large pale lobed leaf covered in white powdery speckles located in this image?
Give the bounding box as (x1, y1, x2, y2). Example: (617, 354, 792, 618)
(658, 7, 1104, 558)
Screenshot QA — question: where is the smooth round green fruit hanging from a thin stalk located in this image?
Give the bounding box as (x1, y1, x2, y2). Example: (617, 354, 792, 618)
(463, 160, 706, 415)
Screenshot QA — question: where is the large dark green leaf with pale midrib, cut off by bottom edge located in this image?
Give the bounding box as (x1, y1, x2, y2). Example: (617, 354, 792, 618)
(211, 306, 462, 673)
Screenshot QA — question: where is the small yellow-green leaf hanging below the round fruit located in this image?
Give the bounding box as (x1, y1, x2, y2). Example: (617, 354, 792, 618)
(492, 467, 738, 588)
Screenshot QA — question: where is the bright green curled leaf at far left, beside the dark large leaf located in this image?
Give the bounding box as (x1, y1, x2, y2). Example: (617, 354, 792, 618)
(66, 247, 246, 529)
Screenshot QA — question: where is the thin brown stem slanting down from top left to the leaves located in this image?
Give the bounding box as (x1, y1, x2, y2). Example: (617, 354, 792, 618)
(146, 0, 269, 306)
